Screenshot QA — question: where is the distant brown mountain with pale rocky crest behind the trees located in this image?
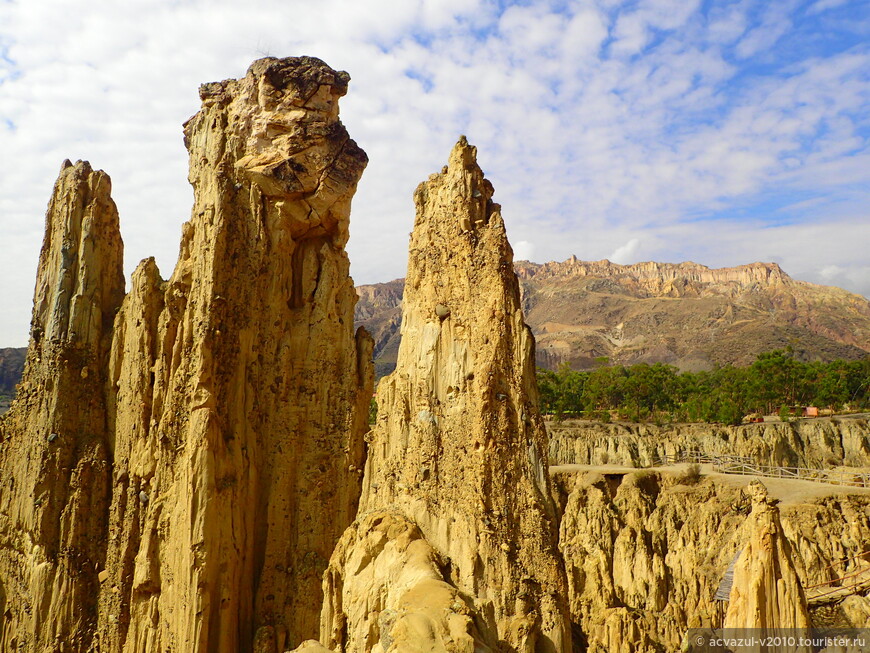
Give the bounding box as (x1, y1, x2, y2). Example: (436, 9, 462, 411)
(355, 257, 870, 376)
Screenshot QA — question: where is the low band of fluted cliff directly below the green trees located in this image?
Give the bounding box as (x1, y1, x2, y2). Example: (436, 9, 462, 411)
(548, 418, 870, 469)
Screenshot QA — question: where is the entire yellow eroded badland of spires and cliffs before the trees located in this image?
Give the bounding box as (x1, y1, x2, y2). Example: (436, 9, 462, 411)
(0, 57, 870, 653)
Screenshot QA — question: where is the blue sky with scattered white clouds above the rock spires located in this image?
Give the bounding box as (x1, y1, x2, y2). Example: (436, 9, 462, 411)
(0, 0, 870, 347)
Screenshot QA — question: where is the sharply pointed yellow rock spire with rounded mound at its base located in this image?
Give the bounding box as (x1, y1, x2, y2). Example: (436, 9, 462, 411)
(321, 137, 570, 651)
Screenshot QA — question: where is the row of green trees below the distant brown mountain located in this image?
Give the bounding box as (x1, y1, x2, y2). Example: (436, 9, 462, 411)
(538, 349, 870, 424)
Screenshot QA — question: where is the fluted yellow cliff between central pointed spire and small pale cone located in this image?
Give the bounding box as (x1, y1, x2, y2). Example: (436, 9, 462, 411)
(558, 472, 744, 653)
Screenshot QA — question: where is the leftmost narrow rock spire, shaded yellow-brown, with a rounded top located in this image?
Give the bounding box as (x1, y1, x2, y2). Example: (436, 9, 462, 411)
(0, 161, 124, 651)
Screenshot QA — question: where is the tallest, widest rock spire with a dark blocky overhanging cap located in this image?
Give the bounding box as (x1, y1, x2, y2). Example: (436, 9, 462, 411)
(100, 57, 371, 653)
